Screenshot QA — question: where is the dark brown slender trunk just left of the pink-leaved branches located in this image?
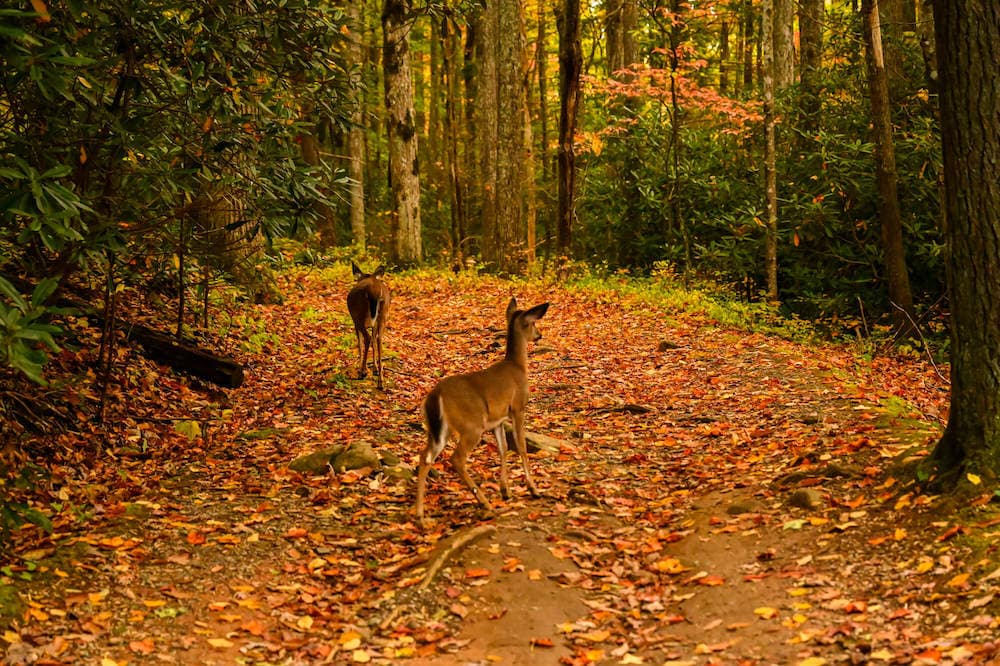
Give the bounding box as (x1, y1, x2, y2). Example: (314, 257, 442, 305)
(556, 0, 583, 258)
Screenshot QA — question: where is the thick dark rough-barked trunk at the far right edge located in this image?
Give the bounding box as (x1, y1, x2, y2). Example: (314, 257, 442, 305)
(933, 0, 1000, 480)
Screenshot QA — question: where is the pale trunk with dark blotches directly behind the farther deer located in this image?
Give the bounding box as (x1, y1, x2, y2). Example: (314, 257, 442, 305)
(382, 0, 423, 264)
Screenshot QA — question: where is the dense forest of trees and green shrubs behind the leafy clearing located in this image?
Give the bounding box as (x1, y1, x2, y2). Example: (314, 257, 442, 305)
(0, 0, 944, 377)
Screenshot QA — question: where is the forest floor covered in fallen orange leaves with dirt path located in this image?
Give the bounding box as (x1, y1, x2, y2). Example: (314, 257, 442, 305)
(0, 270, 1000, 666)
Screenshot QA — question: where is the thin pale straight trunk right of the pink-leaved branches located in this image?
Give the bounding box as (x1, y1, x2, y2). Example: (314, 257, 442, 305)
(760, 0, 778, 302)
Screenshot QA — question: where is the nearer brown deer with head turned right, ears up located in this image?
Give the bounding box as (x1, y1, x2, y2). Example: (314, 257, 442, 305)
(415, 298, 549, 525)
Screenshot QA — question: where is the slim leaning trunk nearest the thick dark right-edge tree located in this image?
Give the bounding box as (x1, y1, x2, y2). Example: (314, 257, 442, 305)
(861, 0, 913, 332)
